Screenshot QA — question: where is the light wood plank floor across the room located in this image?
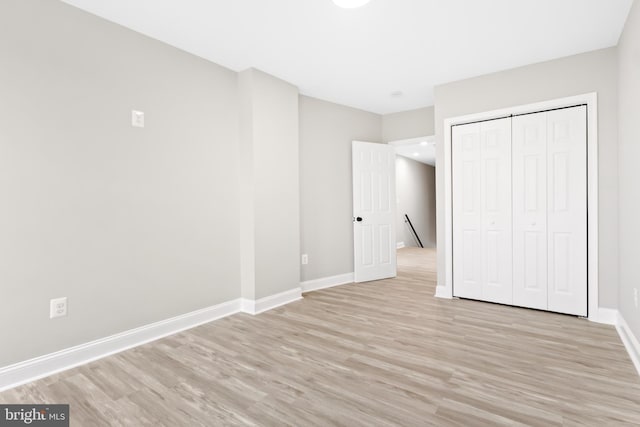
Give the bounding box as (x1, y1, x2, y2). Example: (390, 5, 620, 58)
(0, 248, 640, 427)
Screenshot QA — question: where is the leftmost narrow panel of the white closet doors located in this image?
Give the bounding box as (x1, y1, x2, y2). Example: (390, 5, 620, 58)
(452, 124, 483, 299)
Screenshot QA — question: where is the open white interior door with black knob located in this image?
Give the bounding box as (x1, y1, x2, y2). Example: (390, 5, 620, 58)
(353, 141, 396, 282)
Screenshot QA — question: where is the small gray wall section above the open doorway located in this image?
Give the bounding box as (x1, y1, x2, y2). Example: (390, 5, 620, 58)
(382, 107, 435, 142)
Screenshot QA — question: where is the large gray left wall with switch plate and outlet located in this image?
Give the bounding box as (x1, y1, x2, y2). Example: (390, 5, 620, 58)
(0, 0, 240, 366)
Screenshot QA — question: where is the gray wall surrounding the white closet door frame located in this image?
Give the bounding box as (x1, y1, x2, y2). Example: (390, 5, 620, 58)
(435, 48, 618, 308)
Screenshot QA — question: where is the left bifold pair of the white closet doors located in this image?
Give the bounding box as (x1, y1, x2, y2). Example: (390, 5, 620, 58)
(452, 118, 513, 304)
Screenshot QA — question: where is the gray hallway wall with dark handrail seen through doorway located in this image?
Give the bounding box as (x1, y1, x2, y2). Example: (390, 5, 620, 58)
(396, 156, 436, 248)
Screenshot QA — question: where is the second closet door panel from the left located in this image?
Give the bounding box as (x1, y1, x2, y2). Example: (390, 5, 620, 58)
(480, 118, 513, 304)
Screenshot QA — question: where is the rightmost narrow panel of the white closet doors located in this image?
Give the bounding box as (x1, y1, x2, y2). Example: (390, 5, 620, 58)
(547, 106, 587, 316)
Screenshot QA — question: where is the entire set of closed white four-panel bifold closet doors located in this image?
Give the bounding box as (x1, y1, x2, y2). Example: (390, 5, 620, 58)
(452, 106, 587, 316)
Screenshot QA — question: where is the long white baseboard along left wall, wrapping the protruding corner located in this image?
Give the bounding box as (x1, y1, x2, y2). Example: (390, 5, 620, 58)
(0, 288, 302, 391)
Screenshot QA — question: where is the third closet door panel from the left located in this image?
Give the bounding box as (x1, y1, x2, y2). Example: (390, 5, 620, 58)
(512, 112, 547, 310)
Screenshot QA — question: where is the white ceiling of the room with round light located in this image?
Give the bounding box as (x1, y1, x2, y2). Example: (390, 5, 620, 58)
(64, 0, 632, 114)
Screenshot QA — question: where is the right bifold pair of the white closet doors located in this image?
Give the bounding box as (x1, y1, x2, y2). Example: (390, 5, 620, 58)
(512, 106, 587, 316)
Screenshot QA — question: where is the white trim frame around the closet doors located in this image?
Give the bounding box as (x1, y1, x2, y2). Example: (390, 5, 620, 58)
(435, 92, 600, 323)
